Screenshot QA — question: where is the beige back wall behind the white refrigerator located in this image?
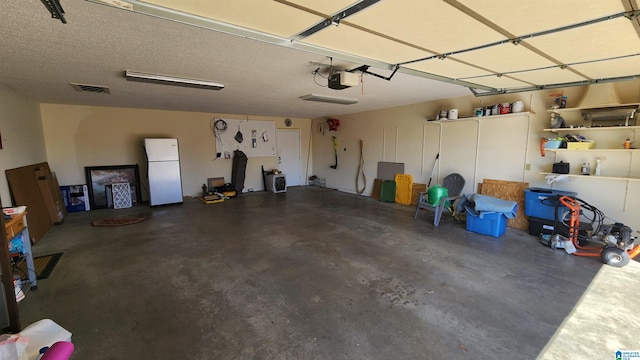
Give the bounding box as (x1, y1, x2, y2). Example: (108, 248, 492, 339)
(41, 104, 311, 200)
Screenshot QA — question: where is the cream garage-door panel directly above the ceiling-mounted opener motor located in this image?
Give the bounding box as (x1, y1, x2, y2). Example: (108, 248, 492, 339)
(301, 24, 434, 64)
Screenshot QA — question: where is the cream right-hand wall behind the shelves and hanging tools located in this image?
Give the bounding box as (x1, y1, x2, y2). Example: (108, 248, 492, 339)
(312, 81, 640, 229)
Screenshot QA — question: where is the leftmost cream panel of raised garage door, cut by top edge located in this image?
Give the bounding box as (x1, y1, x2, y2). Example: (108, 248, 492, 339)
(140, 0, 324, 38)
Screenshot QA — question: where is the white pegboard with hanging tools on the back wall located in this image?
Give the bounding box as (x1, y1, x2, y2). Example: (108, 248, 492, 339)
(212, 118, 276, 158)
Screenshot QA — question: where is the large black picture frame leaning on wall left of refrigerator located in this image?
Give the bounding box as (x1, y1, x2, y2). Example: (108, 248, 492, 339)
(84, 164, 142, 209)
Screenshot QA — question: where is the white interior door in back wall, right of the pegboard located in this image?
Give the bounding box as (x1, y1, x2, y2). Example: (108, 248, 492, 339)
(277, 129, 302, 186)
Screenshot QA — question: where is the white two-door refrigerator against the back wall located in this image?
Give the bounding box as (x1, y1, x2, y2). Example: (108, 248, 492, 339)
(144, 139, 182, 206)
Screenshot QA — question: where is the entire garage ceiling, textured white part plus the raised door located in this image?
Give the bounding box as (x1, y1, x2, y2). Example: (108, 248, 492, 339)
(0, 0, 640, 117)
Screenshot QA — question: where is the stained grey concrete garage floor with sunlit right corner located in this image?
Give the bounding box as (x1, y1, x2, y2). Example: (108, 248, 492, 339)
(19, 187, 640, 360)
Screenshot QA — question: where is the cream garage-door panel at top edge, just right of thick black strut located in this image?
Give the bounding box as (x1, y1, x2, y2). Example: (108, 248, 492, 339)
(347, 0, 505, 53)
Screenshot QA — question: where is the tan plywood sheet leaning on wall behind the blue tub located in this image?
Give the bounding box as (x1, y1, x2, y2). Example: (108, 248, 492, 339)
(480, 179, 529, 230)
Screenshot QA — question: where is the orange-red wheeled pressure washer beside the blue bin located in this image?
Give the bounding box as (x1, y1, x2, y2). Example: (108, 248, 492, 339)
(556, 196, 640, 267)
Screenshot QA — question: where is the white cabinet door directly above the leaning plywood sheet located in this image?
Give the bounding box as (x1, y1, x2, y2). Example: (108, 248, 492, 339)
(477, 114, 529, 182)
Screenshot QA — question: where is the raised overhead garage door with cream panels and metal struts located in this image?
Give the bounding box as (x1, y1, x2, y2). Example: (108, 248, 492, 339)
(114, 0, 640, 93)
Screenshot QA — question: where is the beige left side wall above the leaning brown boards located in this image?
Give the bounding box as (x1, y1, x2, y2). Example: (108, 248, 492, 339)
(0, 85, 47, 207)
